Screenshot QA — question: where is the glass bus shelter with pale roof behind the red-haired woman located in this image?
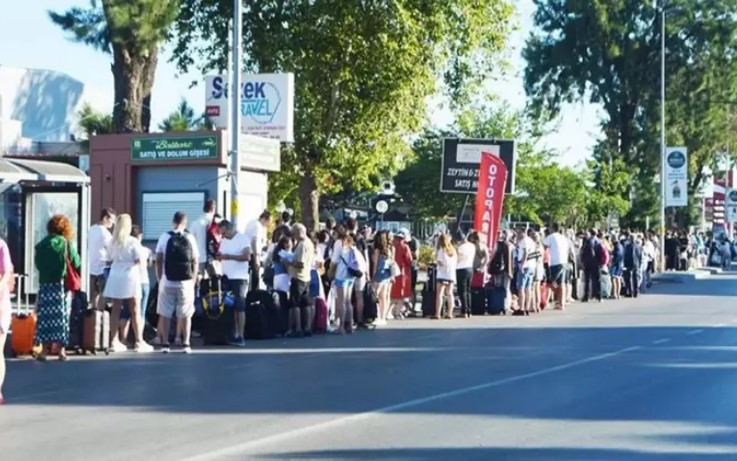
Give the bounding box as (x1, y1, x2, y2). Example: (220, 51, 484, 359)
(0, 157, 90, 294)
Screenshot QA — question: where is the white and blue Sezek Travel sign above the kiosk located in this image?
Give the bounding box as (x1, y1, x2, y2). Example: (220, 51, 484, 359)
(205, 74, 294, 142)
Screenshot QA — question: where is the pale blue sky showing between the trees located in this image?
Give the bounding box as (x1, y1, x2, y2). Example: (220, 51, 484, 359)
(0, 0, 599, 165)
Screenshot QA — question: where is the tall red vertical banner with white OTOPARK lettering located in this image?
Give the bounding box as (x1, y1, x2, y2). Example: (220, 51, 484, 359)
(473, 152, 507, 249)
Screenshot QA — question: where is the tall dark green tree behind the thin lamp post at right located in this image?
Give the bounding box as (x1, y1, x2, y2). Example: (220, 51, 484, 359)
(524, 0, 737, 224)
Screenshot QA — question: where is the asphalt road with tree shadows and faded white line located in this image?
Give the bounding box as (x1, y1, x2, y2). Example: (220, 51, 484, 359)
(0, 276, 737, 461)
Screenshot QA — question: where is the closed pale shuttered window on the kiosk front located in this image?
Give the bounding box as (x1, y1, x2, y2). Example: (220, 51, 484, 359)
(141, 192, 205, 240)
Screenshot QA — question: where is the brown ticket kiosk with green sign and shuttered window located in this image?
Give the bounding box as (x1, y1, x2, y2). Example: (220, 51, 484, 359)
(90, 131, 279, 244)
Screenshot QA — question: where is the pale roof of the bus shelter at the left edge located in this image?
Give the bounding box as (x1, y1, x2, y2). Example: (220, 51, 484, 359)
(0, 158, 90, 184)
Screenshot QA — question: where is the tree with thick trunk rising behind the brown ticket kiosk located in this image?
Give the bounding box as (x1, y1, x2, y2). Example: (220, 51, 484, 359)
(49, 0, 179, 133)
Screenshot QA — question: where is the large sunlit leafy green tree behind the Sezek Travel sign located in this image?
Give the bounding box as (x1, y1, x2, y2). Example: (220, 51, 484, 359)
(174, 0, 512, 228)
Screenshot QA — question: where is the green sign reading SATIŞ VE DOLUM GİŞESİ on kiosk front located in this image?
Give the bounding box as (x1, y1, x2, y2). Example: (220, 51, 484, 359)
(131, 135, 219, 162)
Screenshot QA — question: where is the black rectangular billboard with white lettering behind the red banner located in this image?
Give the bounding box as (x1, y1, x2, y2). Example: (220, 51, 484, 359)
(440, 138, 516, 194)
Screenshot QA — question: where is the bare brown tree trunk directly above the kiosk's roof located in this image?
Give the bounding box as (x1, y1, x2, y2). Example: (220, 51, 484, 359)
(112, 44, 146, 133)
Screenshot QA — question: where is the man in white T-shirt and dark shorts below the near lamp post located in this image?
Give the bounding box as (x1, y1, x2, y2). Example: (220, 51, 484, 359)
(218, 220, 252, 347)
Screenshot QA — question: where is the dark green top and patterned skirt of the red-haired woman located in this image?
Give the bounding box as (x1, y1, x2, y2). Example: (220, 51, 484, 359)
(35, 235, 80, 345)
